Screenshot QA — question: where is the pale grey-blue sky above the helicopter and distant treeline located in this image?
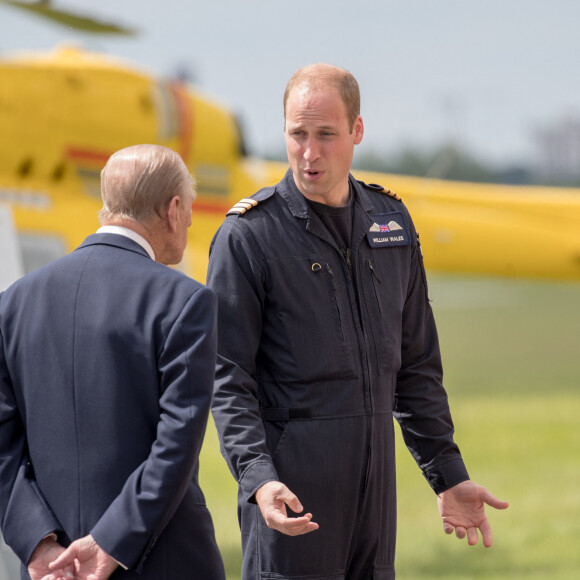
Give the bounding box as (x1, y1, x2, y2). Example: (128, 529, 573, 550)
(0, 0, 580, 166)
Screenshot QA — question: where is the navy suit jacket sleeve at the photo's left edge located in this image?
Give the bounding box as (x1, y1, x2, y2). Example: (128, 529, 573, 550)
(0, 320, 62, 563)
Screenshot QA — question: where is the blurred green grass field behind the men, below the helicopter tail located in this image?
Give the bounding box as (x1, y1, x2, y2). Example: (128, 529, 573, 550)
(201, 275, 580, 580)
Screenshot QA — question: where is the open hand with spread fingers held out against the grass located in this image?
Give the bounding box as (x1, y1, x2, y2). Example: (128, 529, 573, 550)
(437, 481, 509, 548)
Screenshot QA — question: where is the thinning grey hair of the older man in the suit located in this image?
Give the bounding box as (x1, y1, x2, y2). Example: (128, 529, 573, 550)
(99, 145, 195, 223)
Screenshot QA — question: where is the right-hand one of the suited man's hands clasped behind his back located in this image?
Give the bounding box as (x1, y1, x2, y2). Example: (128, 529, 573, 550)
(49, 535, 118, 580)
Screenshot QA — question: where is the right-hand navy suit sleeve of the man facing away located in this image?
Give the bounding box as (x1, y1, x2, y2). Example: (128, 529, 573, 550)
(91, 287, 217, 571)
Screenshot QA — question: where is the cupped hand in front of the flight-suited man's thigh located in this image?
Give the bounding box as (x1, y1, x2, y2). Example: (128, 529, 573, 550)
(256, 481, 318, 536)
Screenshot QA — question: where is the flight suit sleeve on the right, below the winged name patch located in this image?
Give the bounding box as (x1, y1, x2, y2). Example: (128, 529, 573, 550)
(394, 231, 469, 493)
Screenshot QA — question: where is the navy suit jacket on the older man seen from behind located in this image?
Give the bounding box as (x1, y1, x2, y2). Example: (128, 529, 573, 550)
(0, 234, 224, 580)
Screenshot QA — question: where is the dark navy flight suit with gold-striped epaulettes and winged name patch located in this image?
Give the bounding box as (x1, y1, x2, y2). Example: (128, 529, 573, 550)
(208, 171, 468, 580)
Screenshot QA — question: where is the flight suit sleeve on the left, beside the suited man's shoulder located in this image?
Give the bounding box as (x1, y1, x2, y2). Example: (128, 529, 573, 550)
(207, 218, 278, 501)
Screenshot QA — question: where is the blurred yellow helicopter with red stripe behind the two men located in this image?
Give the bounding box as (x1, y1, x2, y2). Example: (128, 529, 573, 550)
(0, 6, 580, 281)
